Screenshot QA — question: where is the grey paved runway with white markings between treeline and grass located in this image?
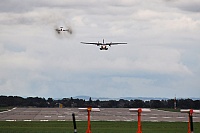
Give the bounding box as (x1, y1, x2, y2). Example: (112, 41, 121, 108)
(0, 108, 200, 122)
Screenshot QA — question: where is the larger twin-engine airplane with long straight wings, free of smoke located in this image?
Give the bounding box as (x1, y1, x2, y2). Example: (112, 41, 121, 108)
(81, 39, 127, 50)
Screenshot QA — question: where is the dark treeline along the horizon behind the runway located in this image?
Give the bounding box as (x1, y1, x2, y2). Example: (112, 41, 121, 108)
(0, 96, 200, 109)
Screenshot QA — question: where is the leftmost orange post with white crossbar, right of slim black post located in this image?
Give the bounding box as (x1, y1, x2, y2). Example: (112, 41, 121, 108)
(79, 107, 100, 133)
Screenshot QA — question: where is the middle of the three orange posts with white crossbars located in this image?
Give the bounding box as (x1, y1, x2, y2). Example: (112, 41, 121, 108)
(129, 108, 151, 133)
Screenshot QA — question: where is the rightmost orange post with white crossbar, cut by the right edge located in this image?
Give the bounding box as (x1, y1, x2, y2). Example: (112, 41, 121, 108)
(181, 109, 200, 133)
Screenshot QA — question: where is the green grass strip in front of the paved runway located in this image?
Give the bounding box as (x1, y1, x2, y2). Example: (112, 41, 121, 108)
(0, 121, 200, 133)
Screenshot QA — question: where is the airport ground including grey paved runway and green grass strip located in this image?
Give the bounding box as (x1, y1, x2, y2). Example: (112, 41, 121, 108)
(0, 108, 200, 133)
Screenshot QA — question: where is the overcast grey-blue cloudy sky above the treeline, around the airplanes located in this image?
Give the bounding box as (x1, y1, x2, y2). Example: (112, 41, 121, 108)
(0, 0, 200, 98)
